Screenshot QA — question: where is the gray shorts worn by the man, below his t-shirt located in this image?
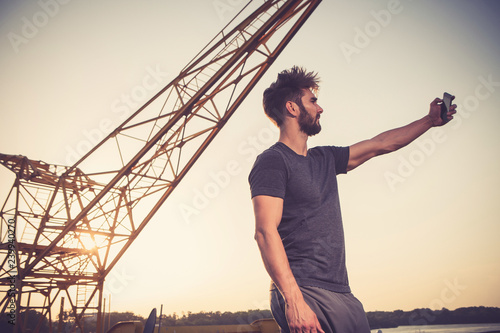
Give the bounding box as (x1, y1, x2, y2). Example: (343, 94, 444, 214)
(271, 287, 370, 333)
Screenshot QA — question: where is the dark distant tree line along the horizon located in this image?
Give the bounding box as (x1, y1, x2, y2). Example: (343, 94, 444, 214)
(0, 306, 500, 333)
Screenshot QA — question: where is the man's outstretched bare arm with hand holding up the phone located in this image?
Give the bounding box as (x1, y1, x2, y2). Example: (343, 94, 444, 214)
(347, 98, 457, 171)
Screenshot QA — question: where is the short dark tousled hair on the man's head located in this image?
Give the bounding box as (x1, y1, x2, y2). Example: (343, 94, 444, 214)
(263, 66, 319, 126)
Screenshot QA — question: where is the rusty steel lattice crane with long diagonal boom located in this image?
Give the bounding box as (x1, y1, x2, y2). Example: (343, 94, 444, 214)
(0, 0, 321, 332)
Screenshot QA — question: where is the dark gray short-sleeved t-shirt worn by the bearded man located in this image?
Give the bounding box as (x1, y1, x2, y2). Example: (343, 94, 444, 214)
(248, 142, 350, 292)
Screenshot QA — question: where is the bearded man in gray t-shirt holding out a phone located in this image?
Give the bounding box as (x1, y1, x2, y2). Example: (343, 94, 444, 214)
(249, 67, 456, 333)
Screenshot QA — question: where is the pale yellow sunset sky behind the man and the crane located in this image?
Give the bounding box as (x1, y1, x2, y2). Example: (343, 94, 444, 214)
(0, 0, 500, 316)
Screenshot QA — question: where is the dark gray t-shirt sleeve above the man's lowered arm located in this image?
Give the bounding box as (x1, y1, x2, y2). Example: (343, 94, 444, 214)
(248, 150, 287, 198)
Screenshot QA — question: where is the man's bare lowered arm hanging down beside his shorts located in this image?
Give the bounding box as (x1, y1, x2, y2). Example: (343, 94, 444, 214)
(252, 195, 324, 333)
